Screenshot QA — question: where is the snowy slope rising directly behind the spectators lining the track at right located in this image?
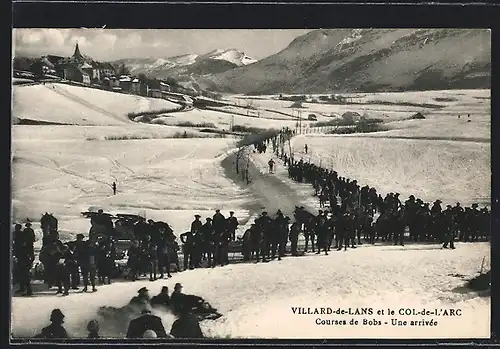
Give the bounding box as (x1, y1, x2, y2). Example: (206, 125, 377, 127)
(285, 136, 491, 206)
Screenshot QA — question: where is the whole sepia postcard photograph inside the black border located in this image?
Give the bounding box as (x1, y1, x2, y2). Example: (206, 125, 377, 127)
(10, 28, 492, 343)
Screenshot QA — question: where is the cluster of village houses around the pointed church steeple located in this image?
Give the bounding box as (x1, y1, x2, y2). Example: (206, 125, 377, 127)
(25, 43, 221, 99)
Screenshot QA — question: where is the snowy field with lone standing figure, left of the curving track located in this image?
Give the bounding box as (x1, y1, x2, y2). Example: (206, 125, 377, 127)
(12, 136, 254, 242)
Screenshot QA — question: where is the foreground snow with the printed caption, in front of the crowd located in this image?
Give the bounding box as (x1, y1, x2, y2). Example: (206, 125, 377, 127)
(12, 243, 490, 339)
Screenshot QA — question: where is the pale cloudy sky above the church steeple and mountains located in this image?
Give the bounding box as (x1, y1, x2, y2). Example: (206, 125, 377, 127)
(13, 28, 311, 61)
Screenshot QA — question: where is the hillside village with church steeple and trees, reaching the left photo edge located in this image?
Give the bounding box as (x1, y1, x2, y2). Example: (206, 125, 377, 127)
(13, 43, 220, 99)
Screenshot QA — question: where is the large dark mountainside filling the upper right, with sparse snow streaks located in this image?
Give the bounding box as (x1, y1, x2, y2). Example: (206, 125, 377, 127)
(208, 29, 491, 94)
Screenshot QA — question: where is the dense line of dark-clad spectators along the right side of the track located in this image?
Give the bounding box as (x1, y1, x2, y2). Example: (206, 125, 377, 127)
(264, 129, 491, 249)
